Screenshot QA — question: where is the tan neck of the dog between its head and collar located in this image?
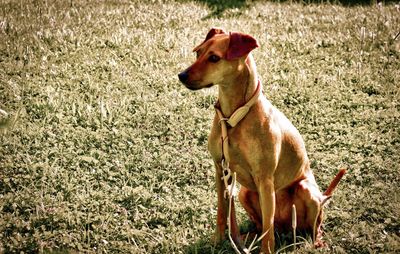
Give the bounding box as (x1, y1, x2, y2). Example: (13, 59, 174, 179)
(218, 54, 258, 117)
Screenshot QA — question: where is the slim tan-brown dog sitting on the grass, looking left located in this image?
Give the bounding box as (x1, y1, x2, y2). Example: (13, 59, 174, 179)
(178, 28, 345, 253)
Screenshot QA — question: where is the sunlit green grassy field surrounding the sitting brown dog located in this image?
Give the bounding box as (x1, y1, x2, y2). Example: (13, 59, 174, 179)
(0, 0, 400, 253)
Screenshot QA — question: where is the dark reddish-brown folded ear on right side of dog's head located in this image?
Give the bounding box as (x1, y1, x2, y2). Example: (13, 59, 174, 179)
(226, 32, 258, 60)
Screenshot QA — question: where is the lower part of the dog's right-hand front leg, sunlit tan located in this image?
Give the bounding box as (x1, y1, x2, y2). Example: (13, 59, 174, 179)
(258, 179, 275, 253)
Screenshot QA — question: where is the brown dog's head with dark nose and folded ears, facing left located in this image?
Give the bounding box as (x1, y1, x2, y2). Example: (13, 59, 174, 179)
(178, 28, 258, 90)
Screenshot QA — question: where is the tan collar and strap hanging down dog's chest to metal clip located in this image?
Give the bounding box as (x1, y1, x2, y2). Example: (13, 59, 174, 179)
(214, 81, 261, 198)
